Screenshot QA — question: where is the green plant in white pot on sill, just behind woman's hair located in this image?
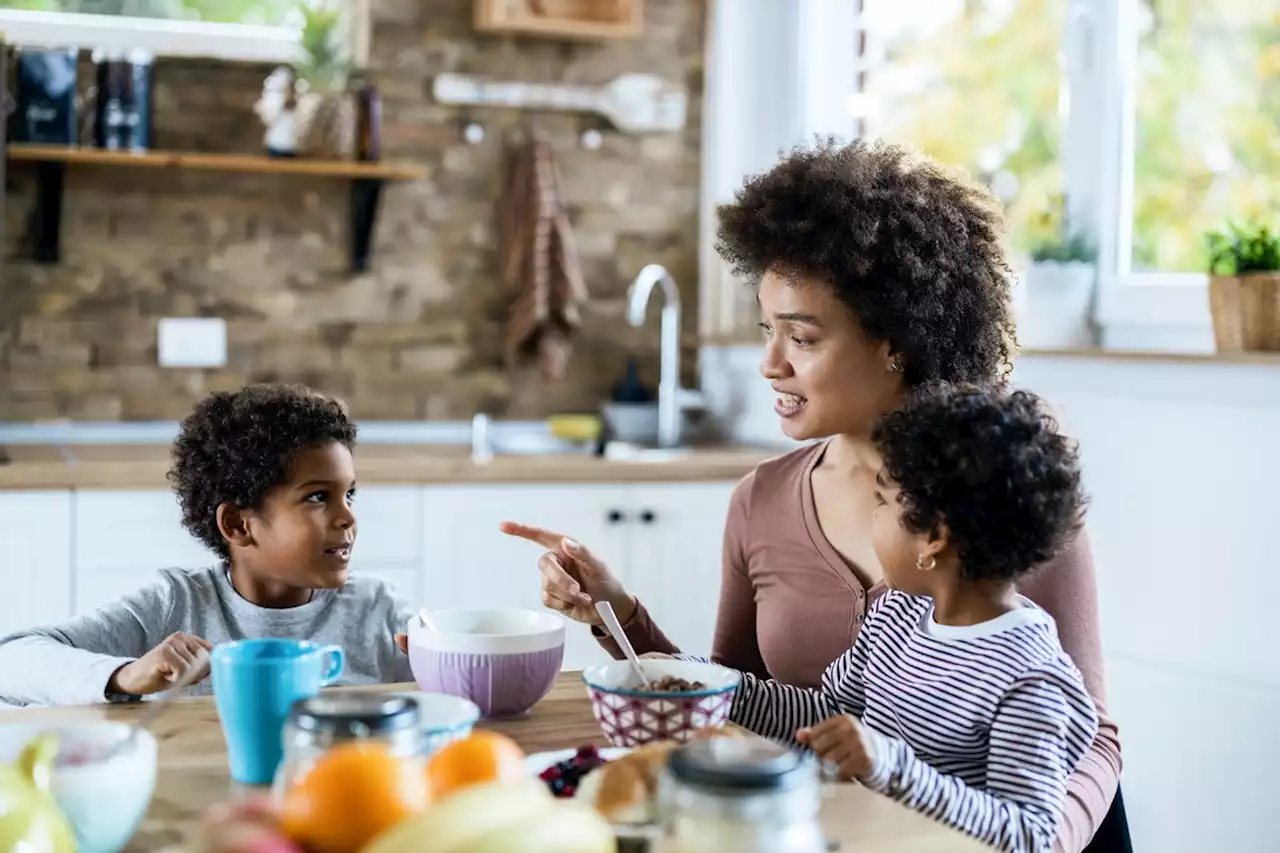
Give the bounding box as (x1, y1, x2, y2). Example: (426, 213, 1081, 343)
(1018, 199, 1097, 348)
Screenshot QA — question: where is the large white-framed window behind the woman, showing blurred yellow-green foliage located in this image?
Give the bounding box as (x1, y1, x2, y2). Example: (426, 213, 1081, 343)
(834, 0, 1280, 348)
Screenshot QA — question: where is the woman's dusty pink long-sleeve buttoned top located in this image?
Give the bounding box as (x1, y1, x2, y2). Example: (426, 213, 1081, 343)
(595, 443, 1121, 853)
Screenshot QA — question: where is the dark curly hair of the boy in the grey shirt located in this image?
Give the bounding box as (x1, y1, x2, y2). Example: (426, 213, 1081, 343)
(169, 384, 356, 560)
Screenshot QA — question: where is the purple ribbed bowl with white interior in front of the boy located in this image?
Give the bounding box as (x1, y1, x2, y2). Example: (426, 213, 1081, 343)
(408, 608, 564, 719)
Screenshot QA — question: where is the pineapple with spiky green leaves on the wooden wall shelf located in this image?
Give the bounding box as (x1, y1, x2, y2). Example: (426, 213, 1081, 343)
(293, 0, 356, 160)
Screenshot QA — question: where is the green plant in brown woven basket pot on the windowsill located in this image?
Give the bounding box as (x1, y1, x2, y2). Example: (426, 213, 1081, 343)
(1208, 223, 1280, 352)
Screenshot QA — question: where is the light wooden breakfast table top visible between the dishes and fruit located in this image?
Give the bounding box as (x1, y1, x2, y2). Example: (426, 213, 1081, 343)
(3, 672, 989, 853)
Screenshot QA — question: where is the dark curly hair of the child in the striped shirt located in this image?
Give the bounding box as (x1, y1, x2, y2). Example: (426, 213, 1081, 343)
(873, 383, 1085, 580)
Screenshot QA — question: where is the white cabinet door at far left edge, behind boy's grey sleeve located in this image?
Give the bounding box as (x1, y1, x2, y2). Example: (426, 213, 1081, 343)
(0, 491, 72, 635)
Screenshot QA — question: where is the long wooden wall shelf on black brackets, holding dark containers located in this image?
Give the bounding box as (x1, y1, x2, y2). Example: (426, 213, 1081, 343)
(6, 145, 426, 272)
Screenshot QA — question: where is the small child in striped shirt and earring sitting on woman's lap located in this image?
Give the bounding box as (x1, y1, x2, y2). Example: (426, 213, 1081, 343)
(732, 387, 1097, 853)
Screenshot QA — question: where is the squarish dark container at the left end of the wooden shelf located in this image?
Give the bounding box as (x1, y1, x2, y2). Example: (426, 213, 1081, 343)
(9, 47, 79, 145)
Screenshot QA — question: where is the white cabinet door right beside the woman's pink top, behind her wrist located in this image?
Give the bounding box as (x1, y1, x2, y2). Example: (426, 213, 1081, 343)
(626, 482, 737, 656)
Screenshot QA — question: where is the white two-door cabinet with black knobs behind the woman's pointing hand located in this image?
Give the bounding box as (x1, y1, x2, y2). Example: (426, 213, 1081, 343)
(422, 483, 735, 670)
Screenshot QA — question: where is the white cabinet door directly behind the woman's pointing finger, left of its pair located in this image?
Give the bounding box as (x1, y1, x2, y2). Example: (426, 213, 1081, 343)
(422, 484, 627, 670)
